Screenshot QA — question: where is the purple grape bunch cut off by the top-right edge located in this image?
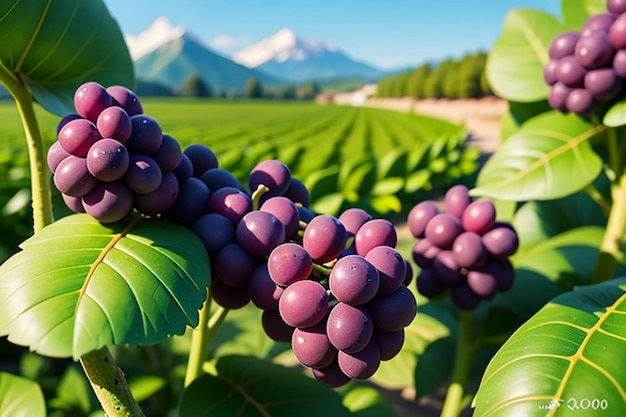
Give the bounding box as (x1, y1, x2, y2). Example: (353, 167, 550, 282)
(543, 0, 626, 115)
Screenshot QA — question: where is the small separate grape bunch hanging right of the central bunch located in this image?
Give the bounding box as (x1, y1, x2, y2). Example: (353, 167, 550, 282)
(407, 185, 519, 310)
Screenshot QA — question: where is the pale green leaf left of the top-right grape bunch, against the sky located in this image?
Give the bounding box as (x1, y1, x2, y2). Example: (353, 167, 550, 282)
(485, 9, 562, 102)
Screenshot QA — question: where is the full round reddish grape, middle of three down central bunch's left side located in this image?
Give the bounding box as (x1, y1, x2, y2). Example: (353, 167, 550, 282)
(278, 280, 328, 327)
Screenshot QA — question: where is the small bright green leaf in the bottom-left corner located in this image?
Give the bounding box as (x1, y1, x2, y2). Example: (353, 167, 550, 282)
(0, 372, 46, 417)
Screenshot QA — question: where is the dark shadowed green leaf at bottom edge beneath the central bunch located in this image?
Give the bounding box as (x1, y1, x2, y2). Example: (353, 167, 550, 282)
(180, 355, 350, 417)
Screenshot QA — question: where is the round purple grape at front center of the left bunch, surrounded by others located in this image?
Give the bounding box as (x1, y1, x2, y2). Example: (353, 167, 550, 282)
(86, 138, 129, 180)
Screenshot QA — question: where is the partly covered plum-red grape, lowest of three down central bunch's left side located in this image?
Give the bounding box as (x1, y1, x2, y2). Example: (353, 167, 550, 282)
(291, 321, 337, 368)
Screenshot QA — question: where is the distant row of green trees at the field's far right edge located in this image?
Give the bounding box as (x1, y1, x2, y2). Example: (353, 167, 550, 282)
(376, 52, 493, 99)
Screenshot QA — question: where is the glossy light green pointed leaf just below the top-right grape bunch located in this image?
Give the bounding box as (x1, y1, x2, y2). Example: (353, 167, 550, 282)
(472, 112, 605, 201)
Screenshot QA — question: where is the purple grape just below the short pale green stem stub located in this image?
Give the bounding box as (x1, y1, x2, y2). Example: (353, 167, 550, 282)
(235, 210, 285, 256)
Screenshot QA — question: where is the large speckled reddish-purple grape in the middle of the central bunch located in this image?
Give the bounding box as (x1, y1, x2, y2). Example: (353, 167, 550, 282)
(328, 255, 380, 306)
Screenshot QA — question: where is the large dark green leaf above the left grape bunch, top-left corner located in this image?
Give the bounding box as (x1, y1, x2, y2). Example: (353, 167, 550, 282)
(0, 0, 133, 115)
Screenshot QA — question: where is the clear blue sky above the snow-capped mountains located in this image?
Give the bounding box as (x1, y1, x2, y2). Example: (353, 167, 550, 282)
(104, 0, 561, 69)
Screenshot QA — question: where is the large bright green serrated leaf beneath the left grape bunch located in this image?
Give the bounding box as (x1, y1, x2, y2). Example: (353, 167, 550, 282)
(0, 214, 210, 358)
